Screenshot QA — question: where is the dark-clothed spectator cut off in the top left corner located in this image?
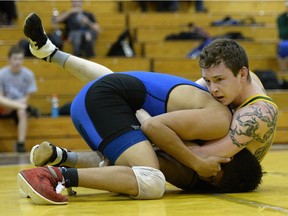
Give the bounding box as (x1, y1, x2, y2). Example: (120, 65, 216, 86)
(0, 0, 18, 25)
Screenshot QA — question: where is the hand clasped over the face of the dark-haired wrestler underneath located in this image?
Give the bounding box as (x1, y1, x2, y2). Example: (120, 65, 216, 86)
(196, 156, 230, 177)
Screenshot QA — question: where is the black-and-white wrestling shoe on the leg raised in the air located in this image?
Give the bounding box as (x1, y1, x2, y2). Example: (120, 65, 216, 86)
(23, 13, 58, 62)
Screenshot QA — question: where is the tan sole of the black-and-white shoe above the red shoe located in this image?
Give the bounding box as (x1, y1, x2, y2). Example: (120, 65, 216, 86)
(30, 142, 53, 167)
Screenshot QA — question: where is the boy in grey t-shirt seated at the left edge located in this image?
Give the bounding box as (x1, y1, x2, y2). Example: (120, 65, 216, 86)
(0, 46, 37, 152)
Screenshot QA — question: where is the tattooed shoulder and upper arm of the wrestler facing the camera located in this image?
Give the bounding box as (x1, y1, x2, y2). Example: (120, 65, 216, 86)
(229, 101, 278, 161)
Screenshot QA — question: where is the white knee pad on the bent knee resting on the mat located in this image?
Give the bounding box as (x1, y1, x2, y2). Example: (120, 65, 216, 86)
(132, 166, 166, 199)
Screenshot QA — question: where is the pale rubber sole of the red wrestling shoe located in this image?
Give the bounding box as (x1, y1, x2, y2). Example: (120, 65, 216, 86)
(17, 173, 68, 205)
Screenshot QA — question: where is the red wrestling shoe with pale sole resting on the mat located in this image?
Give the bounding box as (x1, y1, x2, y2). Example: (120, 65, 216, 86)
(17, 166, 68, 205)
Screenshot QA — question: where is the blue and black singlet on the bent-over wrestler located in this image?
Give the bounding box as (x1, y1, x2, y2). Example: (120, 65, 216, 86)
(71, 71, 207, 163)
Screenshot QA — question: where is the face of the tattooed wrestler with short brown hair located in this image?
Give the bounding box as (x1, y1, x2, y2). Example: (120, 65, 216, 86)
(202, 62, 244, 106)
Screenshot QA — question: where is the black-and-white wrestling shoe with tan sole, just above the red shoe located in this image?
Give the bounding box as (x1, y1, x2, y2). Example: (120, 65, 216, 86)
(30, 141, 68, 166)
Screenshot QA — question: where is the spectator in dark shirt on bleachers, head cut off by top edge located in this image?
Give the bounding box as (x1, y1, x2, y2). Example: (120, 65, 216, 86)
(54, 0, 100, 58)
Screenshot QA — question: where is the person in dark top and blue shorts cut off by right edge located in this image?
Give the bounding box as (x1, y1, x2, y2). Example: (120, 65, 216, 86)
(277, 2, 288, 71)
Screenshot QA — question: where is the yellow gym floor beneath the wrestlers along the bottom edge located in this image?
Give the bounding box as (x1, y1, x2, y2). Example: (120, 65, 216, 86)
(0, 145, 288, 216)
